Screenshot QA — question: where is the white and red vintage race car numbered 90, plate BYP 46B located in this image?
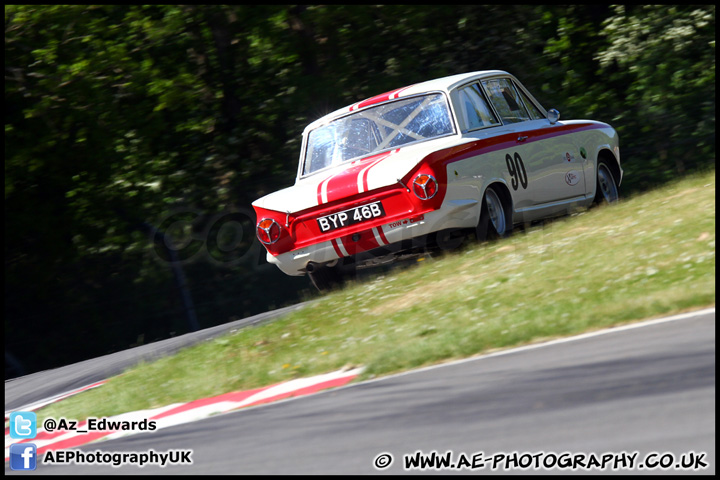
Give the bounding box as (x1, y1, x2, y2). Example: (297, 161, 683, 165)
(253, 70, 623, 290)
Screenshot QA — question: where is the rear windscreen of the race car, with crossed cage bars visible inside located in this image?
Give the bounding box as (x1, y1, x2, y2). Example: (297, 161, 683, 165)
(303, 93, 454, 175)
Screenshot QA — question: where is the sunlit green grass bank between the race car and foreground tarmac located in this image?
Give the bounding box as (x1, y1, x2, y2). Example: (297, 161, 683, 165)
(38, 172, 715, 419)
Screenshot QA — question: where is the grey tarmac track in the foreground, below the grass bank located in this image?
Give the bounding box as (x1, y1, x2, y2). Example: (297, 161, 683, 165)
(6, 309, 715, 475)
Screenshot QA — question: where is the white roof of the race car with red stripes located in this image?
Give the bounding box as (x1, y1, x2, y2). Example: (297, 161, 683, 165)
(305, 70, 512, 132)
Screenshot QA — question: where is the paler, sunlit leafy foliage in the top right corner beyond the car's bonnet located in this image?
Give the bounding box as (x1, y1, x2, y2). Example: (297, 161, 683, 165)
(596, 5, 715, 186)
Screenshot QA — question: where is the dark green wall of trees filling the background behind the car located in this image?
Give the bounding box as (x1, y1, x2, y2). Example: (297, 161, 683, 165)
(5, 5, 715, 371)
